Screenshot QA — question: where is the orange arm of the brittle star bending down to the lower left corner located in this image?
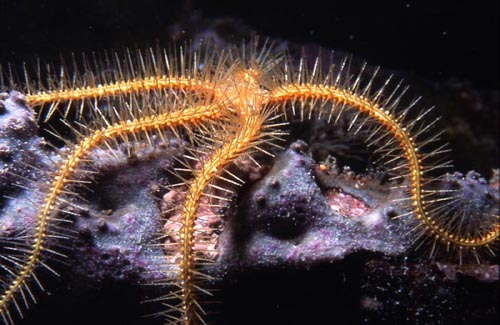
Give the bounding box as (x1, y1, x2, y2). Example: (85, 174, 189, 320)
(0, 104, 224, 324)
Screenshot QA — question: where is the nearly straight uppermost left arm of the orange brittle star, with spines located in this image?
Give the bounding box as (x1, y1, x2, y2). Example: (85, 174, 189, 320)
(15, 46, 227, 121)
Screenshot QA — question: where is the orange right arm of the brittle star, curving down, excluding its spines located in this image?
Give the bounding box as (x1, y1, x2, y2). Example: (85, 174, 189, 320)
(267, 83, 500, 250)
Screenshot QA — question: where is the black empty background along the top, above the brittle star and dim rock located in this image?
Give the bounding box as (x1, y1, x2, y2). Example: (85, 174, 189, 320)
(0, 0, 499, 88)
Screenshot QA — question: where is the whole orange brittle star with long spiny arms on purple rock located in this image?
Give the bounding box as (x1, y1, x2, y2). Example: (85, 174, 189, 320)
(0, 39, 500, 325)
